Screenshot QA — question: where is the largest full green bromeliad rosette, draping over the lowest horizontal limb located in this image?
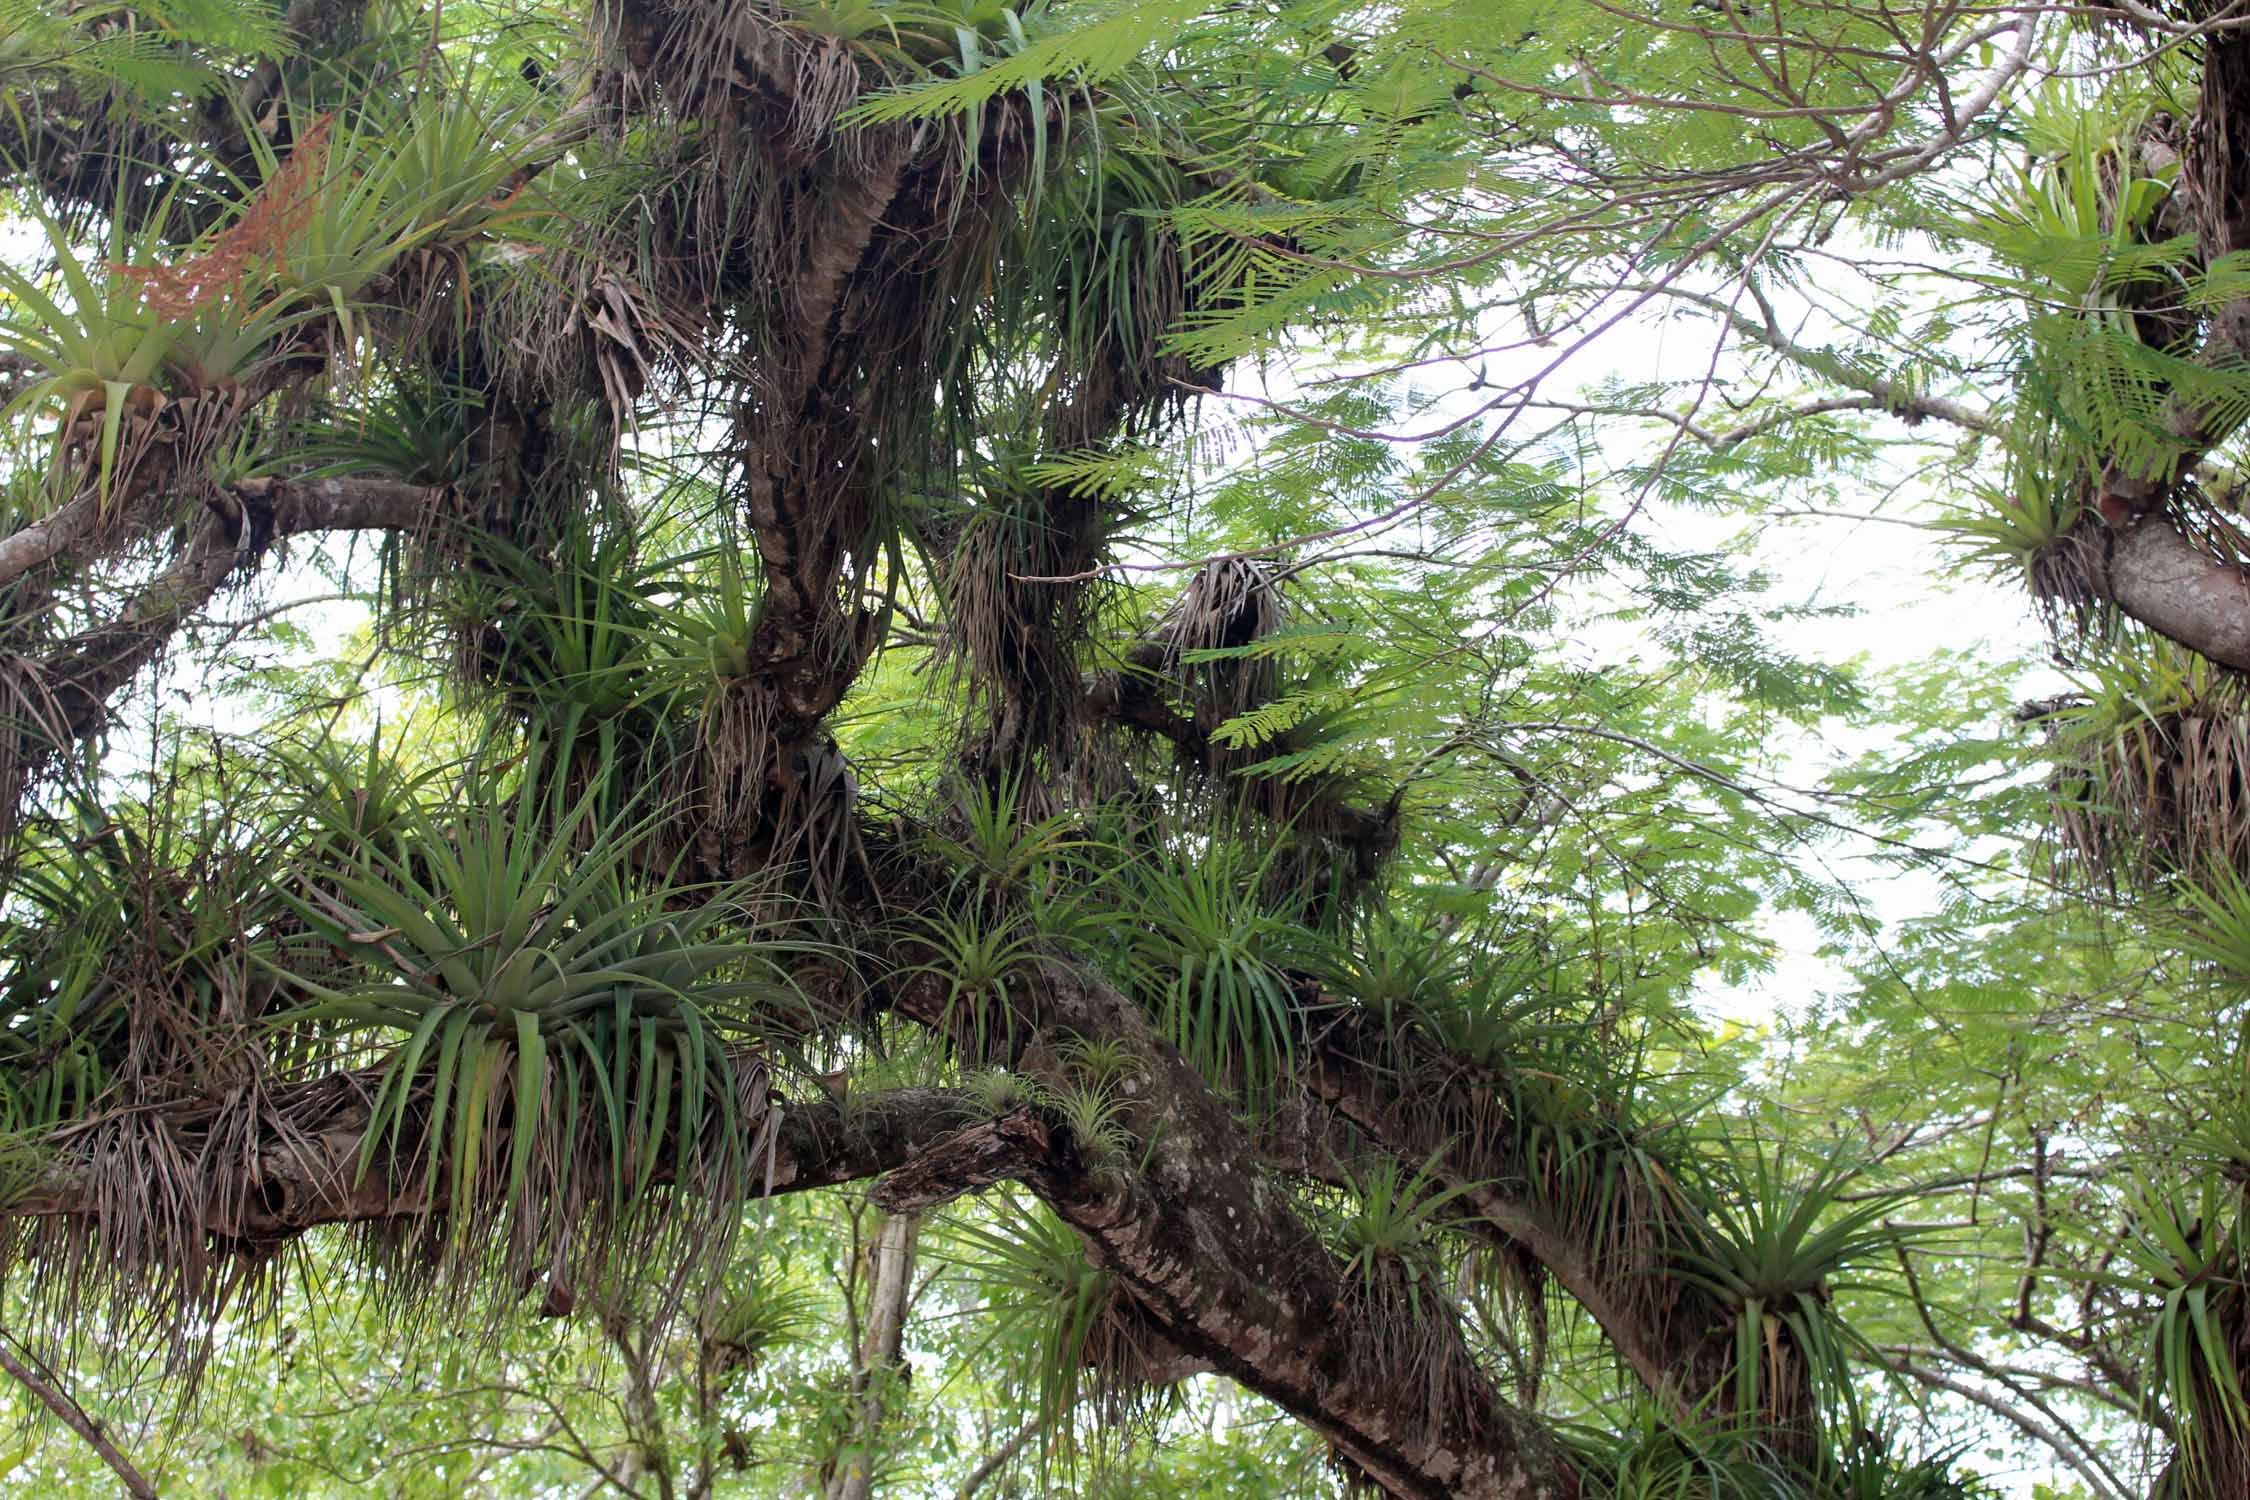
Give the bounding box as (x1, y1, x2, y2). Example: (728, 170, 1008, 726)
(268, 744, 792, 1282)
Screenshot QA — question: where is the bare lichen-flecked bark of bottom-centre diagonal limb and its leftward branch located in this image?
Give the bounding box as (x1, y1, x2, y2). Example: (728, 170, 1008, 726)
(9, 899, 1580, 1500)
